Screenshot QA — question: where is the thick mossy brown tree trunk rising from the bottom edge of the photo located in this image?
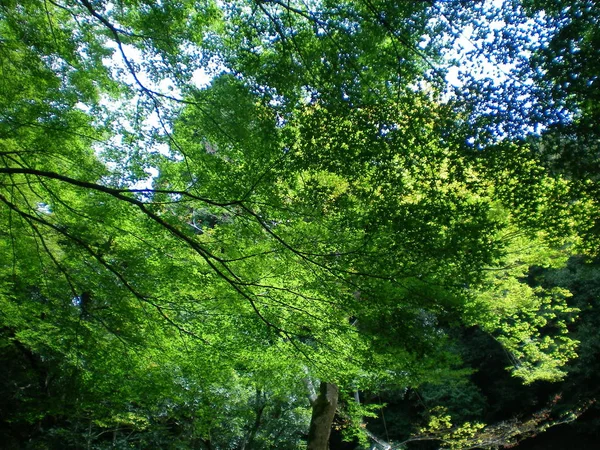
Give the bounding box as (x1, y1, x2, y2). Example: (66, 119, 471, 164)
(307, 381, 338, 450)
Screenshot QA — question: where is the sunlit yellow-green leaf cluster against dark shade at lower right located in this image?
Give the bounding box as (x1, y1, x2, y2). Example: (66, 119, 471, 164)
(469, 231, 578, 383)
